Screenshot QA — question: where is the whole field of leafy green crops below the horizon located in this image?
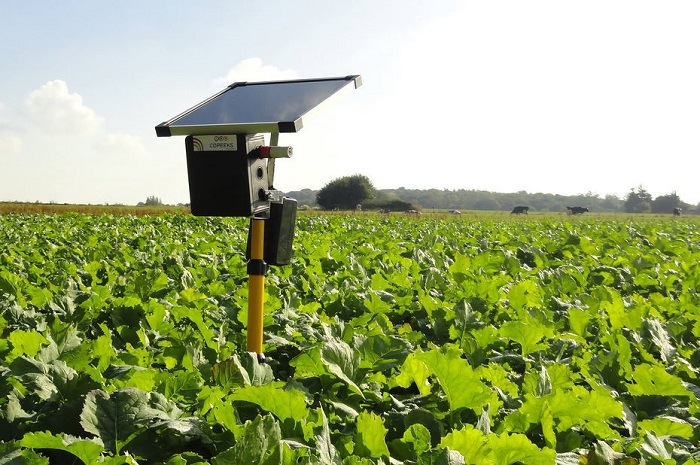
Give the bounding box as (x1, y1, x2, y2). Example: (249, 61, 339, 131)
(0, 213, 700, 465)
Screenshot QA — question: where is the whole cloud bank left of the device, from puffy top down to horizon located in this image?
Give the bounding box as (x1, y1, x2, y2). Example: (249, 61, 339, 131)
(0, 80, 161, 204)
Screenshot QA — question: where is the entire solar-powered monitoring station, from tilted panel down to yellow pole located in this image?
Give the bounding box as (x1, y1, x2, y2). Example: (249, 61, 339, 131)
(156, 75, 362, 354)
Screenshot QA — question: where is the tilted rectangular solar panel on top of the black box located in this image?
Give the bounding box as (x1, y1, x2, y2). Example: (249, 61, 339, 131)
(156, 75, 362, 137)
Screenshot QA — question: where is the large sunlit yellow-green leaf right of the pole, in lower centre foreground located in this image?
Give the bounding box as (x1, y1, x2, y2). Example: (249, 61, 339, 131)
(416, 346, 494, 413)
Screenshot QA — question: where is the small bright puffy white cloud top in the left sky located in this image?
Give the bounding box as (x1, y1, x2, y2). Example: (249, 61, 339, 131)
(26, 79, 103, 135)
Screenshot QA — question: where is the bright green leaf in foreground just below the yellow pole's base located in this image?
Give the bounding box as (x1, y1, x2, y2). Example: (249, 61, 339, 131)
(229, 381, 309, 421)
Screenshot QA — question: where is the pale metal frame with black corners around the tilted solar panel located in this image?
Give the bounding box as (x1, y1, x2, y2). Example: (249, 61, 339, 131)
(155, 75, 362, 137)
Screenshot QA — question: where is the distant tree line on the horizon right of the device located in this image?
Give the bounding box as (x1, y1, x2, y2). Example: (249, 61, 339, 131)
(286, 180, 700, 214)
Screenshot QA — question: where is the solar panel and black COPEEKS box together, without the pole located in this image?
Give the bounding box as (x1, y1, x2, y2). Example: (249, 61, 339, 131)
(156, 75, 362, 217)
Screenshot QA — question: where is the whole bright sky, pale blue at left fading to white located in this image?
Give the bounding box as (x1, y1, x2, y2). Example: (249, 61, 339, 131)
(0, 0, 700, 204)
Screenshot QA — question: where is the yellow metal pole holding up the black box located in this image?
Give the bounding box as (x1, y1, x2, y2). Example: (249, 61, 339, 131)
(247, 218, 267, 355)
